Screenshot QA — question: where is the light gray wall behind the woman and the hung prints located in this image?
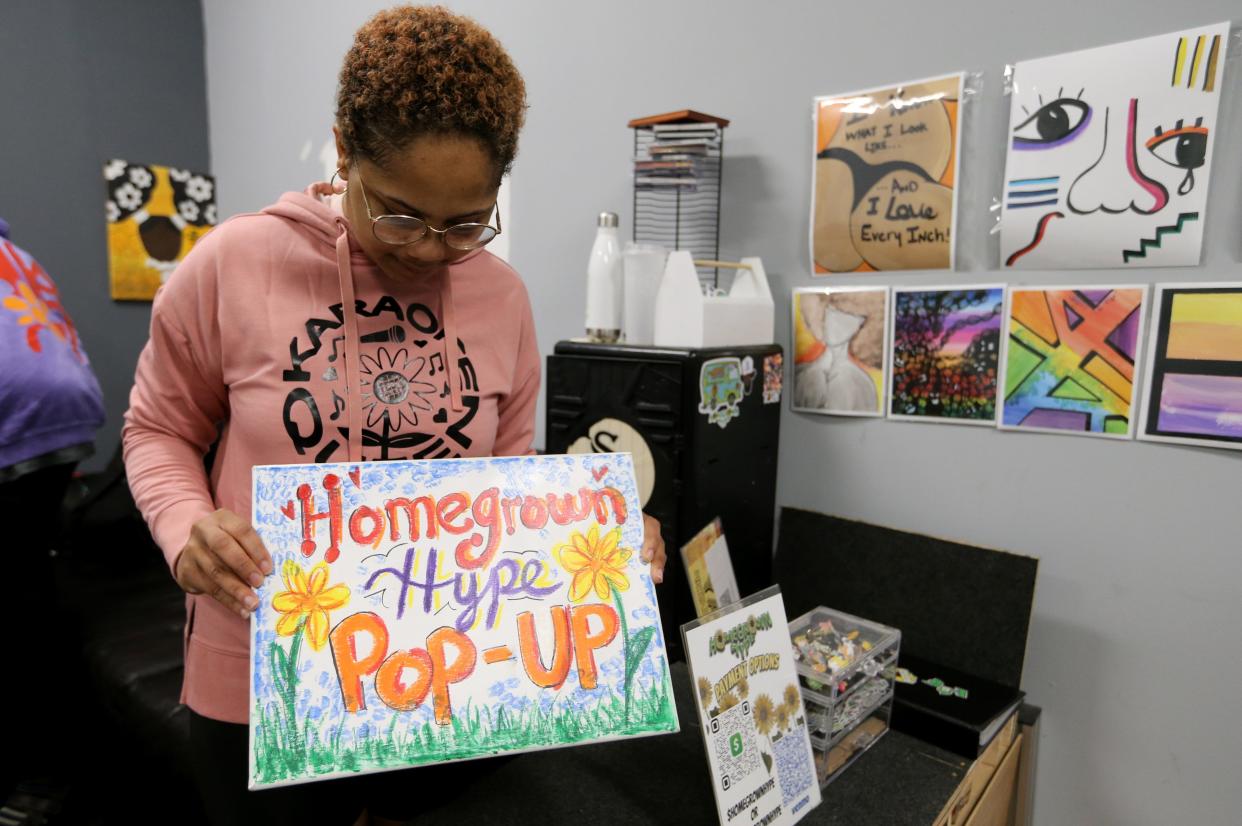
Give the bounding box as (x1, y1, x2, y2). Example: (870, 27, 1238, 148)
(204, 0, 1242, 826)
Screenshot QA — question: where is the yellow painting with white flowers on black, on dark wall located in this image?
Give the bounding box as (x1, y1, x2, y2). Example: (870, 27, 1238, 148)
(103, 160, 216, 301)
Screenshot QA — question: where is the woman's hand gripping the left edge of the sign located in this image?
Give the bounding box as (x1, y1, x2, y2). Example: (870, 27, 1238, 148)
(173, 508, 272, 619)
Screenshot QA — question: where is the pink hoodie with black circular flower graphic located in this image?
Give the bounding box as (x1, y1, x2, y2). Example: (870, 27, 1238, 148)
(122, 190, 539, 723)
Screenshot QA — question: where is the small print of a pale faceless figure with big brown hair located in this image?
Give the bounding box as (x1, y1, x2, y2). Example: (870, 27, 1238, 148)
(792, 287, 888, 416)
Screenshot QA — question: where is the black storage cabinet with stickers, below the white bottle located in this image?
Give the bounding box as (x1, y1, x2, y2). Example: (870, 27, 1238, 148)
(545, 342, 782, 658)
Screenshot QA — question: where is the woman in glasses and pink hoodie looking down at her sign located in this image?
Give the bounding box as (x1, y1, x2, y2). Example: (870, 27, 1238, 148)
(124, 6, 664, 824)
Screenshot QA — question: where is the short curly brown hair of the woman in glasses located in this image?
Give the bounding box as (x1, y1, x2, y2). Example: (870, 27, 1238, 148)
(337, 6, 527, 180)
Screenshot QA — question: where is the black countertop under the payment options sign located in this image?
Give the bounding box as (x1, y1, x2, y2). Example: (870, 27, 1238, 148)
(422, 663, 970, 826)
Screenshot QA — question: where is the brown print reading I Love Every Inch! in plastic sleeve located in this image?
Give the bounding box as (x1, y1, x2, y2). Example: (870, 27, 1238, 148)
(811, 73, 964, 275)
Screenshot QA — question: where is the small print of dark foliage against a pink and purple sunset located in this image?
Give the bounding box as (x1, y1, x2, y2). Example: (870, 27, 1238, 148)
(888, 284, 1005, 425)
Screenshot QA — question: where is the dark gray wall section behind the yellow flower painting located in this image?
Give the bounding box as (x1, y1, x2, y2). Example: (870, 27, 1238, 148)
(0, 0, 210, 470)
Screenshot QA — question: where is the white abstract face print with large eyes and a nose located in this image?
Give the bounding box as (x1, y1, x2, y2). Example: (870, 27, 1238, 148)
(1001, 22, 1230, 270)
